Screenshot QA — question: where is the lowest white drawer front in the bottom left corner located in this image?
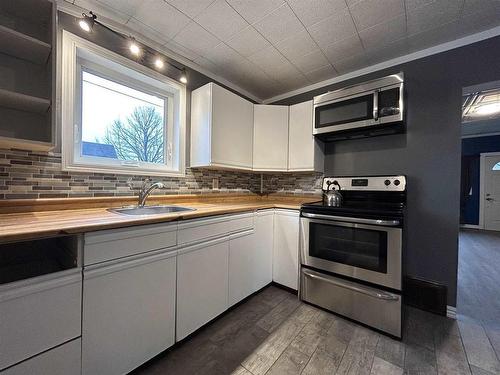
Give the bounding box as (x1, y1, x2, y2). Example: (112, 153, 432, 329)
(0, 338, 82, 375)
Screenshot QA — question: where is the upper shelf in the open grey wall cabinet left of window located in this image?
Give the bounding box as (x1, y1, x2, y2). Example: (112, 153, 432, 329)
(0, 25, 51, 65)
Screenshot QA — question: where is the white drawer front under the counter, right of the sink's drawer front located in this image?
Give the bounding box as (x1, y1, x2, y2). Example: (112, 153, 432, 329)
(178, 212, 254, 245)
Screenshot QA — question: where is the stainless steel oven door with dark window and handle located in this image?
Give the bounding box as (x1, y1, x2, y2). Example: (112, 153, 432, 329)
(300, 213, 402, 290)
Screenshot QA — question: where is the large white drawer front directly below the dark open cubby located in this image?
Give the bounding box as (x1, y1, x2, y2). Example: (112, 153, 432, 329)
(0, 270, 82, 369)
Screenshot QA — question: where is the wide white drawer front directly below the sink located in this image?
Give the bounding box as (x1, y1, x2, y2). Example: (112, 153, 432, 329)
(83, 223, 177, 266)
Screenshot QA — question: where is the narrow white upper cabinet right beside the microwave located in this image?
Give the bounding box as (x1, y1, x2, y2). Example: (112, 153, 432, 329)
(288, 100, 324, 172)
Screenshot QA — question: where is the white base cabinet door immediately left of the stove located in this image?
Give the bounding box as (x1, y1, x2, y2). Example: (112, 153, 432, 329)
(273, 210, 299, 290)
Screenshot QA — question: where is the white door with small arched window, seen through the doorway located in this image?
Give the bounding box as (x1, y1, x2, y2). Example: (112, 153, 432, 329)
(483, 155, 500, 231)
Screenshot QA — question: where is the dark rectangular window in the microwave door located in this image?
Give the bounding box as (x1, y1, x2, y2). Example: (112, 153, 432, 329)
(315, 94, 373, 128)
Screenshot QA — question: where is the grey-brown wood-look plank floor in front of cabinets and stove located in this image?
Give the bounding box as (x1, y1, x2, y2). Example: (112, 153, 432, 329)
(134, 286, 500, 375)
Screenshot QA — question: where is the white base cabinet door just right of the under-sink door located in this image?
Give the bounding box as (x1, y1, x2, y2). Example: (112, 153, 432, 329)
(177, 237, 229, 341)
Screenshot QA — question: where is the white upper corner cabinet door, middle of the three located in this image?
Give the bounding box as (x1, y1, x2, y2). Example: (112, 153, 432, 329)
(253, 104, 288, 171)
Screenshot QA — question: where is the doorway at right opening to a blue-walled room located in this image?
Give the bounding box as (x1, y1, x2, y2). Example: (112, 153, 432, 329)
(457, 81, 500, 328)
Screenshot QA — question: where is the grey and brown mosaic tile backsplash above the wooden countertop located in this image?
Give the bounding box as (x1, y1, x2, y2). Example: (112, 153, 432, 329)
(0, 149, 322, 199)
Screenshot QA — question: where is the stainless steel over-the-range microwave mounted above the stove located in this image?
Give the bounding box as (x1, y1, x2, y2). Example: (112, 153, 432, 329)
(313, 73, 404, 139)
